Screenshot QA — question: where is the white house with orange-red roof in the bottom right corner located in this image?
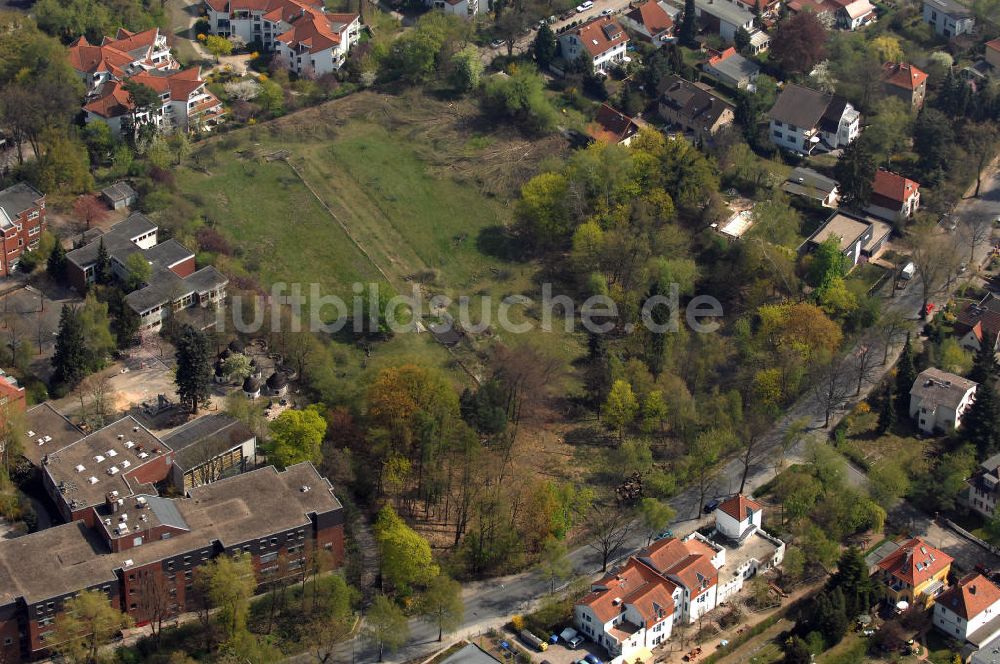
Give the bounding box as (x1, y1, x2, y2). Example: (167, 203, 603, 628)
(933, 573, 1000, 647)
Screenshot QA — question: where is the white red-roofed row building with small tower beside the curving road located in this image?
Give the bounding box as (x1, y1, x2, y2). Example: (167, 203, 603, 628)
(573, 495, 785, 661)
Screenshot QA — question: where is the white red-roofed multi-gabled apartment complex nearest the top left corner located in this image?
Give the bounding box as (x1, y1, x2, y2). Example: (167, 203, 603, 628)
(69, 28, 225, 136)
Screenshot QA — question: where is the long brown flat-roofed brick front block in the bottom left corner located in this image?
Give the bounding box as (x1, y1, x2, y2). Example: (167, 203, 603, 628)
(0, 463, 344, 662)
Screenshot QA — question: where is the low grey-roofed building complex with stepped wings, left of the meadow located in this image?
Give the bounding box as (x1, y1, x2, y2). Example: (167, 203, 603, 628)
(66, 212, 229, 332)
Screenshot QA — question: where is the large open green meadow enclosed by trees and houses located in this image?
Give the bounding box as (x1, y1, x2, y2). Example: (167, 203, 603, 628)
(175, 92, 582, 390)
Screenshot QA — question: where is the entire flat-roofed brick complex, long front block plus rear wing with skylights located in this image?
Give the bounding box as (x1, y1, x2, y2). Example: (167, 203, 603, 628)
(0, 404, 344, 662)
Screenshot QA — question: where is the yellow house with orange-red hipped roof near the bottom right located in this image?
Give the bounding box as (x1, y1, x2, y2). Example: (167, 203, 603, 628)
(875, 537, 953, 607)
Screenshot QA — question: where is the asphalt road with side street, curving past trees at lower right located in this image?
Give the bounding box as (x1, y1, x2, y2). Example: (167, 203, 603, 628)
(291, 167, 1000, 664)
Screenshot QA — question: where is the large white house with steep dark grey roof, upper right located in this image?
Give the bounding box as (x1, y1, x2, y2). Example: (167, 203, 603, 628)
(770, 83, 861, 154)
